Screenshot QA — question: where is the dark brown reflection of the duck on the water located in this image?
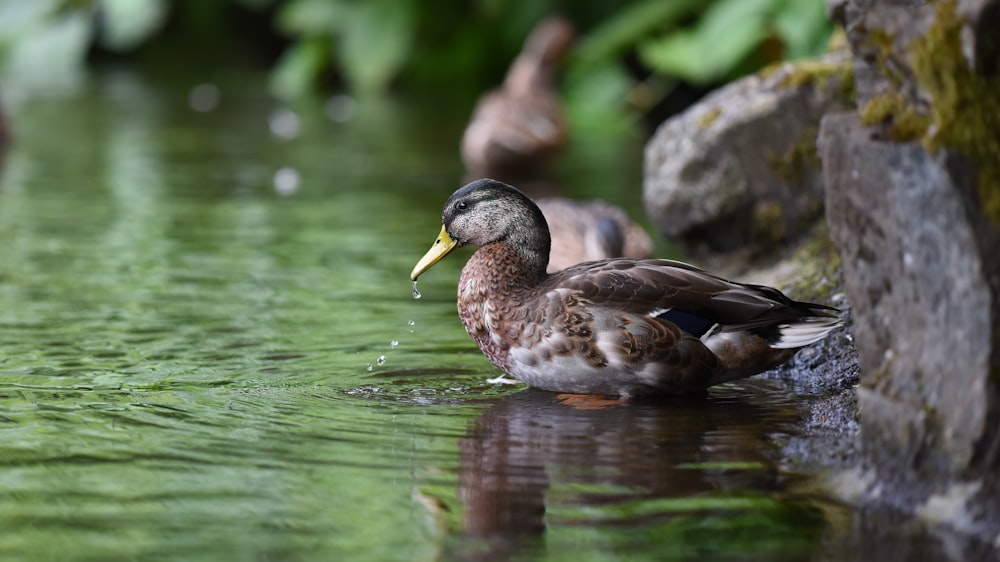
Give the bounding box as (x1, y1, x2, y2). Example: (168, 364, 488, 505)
(449, 381, 824, 560)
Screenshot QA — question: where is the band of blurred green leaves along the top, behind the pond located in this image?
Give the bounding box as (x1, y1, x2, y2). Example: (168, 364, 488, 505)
(0, 0, 831, 113)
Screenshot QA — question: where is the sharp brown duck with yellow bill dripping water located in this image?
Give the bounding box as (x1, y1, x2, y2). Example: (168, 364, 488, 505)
(410, 179, 841, 397)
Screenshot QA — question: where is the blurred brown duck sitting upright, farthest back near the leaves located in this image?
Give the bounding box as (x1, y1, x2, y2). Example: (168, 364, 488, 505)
(461, 16, 575, 177)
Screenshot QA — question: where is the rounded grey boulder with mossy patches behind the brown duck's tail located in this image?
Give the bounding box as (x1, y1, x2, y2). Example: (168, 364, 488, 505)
(644, 52, 853, 253)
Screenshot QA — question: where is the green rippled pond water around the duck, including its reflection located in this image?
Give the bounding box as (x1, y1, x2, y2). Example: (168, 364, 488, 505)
(0, 70, 833, 560)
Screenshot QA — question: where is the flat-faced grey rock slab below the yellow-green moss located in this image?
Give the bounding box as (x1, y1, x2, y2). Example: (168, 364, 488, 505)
(820, 114, 1000, 486)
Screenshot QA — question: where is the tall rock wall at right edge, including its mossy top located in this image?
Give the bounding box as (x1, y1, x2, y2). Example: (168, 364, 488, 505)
(819, 0, 1000, 532)
